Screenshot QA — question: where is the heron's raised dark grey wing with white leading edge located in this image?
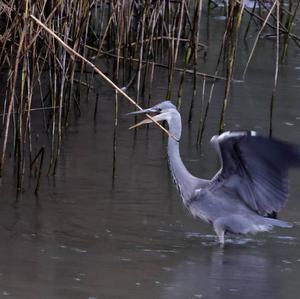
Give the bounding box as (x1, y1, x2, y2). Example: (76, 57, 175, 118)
(209, 132, 300, 215)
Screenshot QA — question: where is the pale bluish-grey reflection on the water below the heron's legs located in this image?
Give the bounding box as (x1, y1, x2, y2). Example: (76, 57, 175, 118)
(161, 248, 280, 298)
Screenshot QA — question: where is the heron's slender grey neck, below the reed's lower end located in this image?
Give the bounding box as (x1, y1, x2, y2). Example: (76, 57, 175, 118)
(168, 136, 199, 203)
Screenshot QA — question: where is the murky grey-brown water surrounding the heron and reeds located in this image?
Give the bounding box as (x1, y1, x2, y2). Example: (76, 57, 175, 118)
(0, 4, 300, 299)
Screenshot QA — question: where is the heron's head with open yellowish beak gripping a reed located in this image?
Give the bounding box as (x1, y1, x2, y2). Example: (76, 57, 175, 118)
(128, 101, 178, 129)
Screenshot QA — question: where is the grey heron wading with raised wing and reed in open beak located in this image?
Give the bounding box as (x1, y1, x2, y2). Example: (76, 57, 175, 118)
(129, 101, 300, 246)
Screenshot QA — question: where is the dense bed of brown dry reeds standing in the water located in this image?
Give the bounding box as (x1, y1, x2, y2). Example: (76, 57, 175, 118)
(0, 0, 300, 193)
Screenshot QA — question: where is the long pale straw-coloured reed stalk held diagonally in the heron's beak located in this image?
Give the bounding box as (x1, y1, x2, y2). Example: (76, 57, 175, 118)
(30, 15, 177, 140)
